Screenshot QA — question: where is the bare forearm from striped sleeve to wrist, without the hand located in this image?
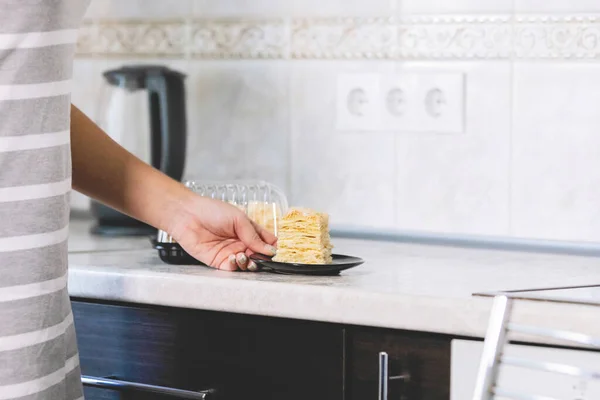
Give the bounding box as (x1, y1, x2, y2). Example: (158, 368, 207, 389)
(71, 106, 190, 230)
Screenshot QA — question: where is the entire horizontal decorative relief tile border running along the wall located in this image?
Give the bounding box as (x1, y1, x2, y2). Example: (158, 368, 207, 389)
(77, 15, 600, 60)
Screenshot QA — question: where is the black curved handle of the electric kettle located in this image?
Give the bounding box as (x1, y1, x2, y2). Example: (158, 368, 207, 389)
(146, 73, 187, 181)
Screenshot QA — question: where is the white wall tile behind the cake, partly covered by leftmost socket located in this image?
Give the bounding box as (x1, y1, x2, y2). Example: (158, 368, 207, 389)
(291, 62, 394, 227)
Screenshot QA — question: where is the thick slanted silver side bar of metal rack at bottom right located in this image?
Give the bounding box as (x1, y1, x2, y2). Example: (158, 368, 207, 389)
(473, 296, 512, 400)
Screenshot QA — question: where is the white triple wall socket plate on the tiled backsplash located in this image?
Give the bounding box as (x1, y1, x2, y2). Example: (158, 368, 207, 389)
(336, 70, 465, 133)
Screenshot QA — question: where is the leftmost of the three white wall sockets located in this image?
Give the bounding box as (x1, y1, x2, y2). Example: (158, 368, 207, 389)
(336, 74, 381, 131)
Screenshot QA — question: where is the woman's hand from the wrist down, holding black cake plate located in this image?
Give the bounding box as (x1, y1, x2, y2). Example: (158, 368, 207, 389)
(165, 194, 277, 271)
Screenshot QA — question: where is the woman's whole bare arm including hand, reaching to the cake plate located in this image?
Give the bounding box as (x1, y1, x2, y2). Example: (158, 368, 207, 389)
(71, 106, 276, 270)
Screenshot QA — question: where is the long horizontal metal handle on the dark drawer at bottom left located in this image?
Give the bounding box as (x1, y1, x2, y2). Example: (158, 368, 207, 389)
(81, 375, 215, 400)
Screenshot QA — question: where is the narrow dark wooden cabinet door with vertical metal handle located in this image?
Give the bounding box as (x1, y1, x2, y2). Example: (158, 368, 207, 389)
(348, 329, 450, 400)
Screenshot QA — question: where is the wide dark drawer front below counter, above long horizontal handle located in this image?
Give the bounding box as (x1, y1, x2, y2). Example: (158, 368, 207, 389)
(73, 301, 344, 400)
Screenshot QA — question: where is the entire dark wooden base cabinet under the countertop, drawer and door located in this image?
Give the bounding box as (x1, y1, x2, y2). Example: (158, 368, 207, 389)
(73, 299, 451, 400)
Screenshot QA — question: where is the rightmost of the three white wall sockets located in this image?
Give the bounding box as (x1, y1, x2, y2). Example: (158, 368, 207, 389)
(411, 72, 465, 133)
